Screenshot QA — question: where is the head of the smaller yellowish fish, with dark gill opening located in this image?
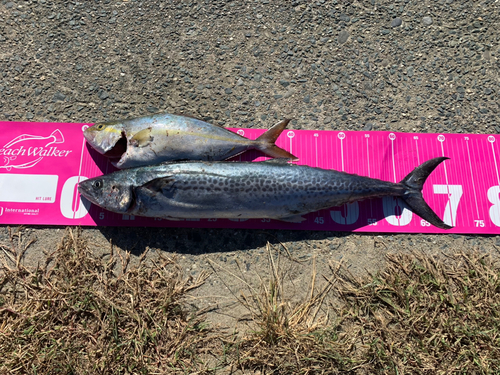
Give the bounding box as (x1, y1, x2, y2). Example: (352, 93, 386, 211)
(83, 121, 127, 159)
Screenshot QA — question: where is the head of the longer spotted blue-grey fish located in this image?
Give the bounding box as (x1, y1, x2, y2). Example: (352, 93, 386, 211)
(78, 173, 134, 213)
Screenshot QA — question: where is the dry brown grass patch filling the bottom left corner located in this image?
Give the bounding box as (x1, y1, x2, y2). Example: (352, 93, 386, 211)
(0, 230, 217, 374)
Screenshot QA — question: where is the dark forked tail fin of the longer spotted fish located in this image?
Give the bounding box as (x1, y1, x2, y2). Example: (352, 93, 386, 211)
(400, 157, 453, 229)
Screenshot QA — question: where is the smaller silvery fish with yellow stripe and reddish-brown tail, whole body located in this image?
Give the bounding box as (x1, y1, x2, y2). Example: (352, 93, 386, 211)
(83, 114, 297, 169)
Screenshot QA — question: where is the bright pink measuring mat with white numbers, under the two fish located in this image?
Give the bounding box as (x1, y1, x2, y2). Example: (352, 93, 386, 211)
(0, 122, 500, 234)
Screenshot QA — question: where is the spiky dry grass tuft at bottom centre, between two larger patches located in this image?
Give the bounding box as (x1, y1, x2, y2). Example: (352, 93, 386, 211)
(214, 244, 354, 374)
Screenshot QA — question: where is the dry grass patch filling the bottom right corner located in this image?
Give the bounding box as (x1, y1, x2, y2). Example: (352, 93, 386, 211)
(335, 251, 500, 374)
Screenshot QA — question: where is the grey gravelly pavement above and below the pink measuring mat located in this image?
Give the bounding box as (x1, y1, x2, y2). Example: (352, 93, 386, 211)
(0, 0, 500, 326)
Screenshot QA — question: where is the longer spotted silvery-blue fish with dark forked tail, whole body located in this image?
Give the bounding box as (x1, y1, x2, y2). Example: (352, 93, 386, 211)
(78, 157, 451, 229)
